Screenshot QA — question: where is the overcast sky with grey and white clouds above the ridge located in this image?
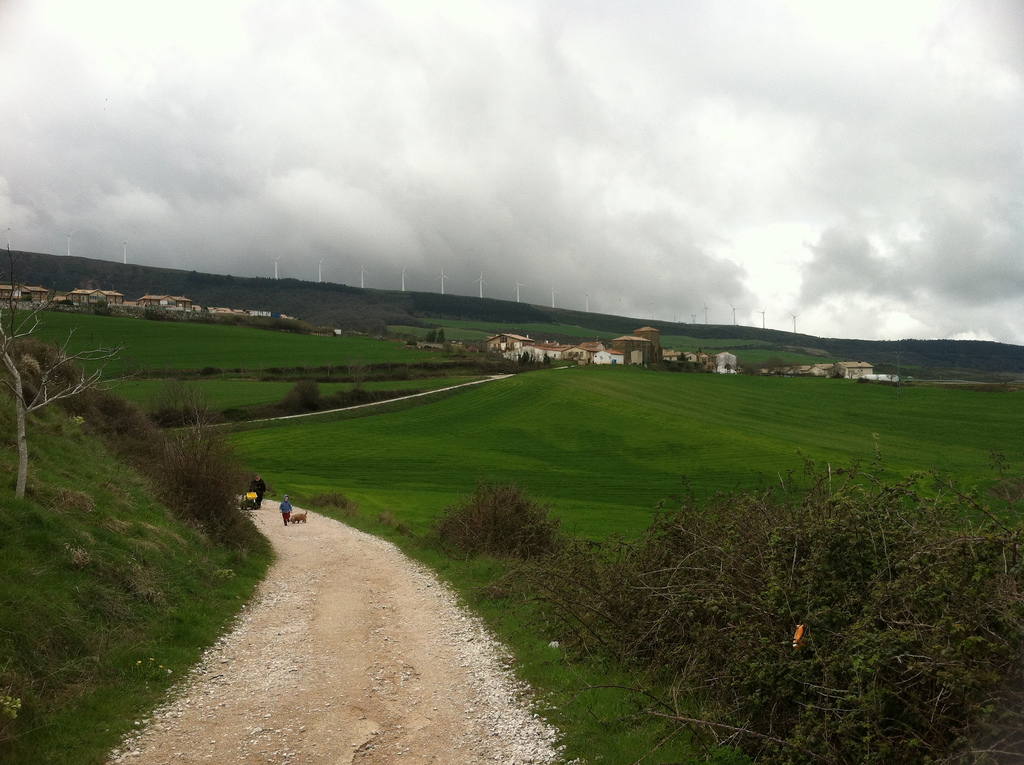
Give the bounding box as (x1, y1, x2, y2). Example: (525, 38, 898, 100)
(0, 0, 1024, 344)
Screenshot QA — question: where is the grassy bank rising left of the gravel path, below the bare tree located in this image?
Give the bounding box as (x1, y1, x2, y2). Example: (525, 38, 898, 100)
(0, 407, 269, 765)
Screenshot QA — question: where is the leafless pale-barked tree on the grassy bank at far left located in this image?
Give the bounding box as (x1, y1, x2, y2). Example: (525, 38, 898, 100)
(0, 247, 123, 499)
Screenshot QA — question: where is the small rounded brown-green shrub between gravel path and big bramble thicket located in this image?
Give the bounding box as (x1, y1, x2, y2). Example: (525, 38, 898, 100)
(434, 480, 560, 559)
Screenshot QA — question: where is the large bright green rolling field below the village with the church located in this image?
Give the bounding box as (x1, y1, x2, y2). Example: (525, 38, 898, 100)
(232, 368, 1024, 536)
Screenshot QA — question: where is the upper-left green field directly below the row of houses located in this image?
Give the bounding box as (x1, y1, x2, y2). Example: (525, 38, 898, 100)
(30, 311, 437, 373)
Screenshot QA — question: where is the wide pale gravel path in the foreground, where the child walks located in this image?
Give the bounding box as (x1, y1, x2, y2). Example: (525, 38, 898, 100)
(109, 502, 558, 765)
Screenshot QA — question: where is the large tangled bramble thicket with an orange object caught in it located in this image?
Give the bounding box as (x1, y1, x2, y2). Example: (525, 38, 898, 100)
(520, 462, 1024, 765)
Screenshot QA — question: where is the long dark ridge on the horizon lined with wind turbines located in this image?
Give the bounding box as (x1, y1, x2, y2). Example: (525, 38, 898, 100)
(8, 252, 1024, 376)
